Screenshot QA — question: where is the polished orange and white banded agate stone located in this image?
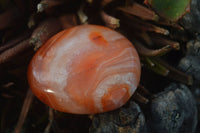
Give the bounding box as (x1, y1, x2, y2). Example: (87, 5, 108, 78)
(28, 25, 141, 114)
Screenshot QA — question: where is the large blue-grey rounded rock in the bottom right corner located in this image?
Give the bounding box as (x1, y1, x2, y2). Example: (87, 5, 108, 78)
(147, 83, 197, 133)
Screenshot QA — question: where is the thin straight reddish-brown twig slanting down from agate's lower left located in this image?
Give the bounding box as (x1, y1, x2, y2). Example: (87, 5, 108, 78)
(14, 89, 34, 133)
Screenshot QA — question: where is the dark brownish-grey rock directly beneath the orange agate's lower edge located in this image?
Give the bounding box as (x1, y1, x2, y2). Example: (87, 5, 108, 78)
(90, 102, 147, 133)
